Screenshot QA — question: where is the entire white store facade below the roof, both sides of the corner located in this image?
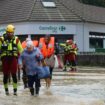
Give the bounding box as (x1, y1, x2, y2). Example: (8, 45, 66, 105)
(0, 22, 105, 52)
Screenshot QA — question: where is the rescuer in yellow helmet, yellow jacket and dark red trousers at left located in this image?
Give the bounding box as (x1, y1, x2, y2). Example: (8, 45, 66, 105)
(0, 24, 23, 95)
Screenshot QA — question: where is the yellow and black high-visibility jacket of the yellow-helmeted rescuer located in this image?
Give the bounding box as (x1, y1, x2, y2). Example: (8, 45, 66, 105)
(0, 36, 23, 57)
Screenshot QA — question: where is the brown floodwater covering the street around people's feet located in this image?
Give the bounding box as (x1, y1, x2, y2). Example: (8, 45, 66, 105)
(0, 67, 105, 105)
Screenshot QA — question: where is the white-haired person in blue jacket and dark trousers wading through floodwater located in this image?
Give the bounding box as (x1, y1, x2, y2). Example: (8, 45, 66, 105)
(19, 41, 43, 96)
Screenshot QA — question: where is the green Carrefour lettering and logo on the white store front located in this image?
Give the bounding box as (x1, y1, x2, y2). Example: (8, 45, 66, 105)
(39, 26, 66, 33)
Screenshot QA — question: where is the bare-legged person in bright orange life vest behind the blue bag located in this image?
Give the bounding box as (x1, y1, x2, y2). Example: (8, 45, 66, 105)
(39, 35, 55, 88)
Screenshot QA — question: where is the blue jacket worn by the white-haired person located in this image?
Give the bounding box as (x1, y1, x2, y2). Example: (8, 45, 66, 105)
(18, 47, 43, 75)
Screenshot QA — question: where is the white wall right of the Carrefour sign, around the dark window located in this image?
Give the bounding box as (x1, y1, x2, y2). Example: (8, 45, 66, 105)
(75, 23, 105, 52)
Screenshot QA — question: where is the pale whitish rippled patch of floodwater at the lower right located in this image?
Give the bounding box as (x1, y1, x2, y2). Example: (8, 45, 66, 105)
(52, 84, 105, 99)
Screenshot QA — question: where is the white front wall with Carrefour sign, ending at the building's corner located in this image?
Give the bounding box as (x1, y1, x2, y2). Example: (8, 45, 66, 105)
(0, 22, 84, 51)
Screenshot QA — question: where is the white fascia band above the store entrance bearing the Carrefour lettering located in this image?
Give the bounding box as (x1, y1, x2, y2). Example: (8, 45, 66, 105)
(0, 22, 76, 35)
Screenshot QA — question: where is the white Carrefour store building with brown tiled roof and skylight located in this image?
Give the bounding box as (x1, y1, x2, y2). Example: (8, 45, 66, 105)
(0, 0, 105, 52)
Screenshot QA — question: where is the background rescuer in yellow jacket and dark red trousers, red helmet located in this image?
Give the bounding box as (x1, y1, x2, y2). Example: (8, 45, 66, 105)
(60, 39, 78, 72)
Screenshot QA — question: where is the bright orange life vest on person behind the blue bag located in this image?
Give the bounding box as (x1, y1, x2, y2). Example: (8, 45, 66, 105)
(39, 37, 55, 58)
